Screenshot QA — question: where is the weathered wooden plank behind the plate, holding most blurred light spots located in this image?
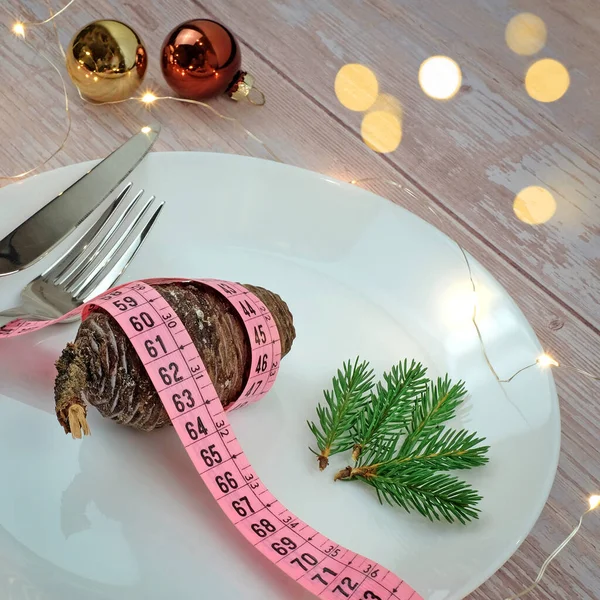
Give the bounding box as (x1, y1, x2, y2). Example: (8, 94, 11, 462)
(194, 0, 600, 328)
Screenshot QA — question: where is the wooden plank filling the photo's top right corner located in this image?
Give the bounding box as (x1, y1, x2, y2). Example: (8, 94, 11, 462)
(406, 0, 600, 158)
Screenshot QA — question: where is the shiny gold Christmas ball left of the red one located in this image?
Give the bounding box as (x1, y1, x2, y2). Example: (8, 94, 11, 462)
(66, 21, 148, 102)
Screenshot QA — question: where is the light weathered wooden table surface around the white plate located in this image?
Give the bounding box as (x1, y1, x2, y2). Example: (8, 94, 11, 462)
(0, 0, 600, 600)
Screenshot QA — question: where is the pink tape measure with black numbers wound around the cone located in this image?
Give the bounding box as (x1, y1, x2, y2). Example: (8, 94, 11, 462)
(0, 279, 423, 600)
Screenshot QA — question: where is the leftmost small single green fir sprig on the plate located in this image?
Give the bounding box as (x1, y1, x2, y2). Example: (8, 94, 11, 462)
(307, 358, 374, 471)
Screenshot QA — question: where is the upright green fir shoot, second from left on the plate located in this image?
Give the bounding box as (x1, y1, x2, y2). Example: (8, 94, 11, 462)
(352, 360, 428, 461)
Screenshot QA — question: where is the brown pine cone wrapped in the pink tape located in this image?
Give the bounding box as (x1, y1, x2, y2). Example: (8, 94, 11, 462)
(54, 283, 296, 438)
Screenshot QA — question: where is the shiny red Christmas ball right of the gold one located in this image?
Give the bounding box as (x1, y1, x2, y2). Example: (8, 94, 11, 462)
(161, 19, 246, 100)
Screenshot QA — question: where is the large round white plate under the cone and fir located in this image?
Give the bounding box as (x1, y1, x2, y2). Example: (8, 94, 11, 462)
(0, 153, 560, 600)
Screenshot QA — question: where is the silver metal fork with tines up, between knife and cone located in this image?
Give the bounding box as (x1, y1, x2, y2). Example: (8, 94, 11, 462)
(0, 183, 164, 326)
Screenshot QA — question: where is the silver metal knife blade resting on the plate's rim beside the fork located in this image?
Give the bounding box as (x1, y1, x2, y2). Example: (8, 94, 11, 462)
(0, 124, 160, 277)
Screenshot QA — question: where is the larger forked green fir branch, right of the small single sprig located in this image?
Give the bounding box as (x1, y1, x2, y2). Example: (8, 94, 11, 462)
(311, 361, 489, 524)
